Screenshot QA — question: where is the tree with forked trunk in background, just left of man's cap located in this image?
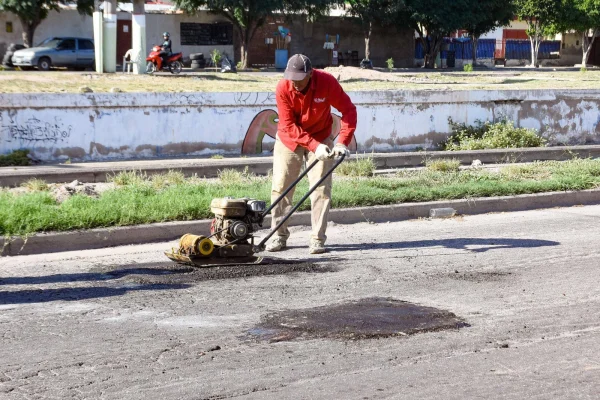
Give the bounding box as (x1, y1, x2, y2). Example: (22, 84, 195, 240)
(175, 0, 332, 68)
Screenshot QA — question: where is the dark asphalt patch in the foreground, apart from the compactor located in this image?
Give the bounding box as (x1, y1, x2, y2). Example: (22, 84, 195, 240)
(245, 297, 469, 342)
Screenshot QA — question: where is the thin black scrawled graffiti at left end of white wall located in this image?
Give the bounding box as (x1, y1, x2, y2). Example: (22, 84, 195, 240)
(0, 115, 73, 144)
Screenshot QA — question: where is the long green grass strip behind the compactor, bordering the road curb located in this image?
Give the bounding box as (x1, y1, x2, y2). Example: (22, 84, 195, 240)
(0, 159, 600, 236)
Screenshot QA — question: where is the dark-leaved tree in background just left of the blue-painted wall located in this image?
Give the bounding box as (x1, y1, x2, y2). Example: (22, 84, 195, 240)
(393, 0, 478, 68)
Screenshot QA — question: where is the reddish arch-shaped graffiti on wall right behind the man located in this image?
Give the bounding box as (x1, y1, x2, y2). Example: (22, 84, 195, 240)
(242, 110, 357, 155)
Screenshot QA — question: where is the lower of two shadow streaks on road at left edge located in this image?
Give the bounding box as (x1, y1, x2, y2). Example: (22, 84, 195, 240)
(0, 284, 190, 305)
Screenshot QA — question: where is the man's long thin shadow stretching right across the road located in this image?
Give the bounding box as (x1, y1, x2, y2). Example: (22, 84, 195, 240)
(328, 238, 560, 253)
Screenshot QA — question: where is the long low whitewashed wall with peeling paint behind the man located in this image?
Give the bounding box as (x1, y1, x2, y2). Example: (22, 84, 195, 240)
(0, 90, 600, 161)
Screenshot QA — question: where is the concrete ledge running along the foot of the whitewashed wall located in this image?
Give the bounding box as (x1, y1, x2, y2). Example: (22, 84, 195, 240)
(0, 145, 600, 187)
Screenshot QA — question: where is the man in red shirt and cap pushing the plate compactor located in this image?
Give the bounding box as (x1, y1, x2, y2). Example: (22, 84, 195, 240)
(266, 54, 356, 254)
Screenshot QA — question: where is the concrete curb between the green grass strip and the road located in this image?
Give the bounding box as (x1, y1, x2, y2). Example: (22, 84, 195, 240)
(0, 189, 600, 256)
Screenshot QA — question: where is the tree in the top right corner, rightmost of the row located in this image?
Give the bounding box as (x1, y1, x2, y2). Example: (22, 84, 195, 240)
(555, 0, 600, 67)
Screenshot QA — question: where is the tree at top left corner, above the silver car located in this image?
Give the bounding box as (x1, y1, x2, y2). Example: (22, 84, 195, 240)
(0, 0, 94, 47)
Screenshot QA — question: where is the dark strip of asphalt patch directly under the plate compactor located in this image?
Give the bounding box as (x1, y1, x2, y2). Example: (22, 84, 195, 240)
(95, 261, 338, 284)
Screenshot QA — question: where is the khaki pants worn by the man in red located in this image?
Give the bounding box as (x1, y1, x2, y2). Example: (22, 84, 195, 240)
(271, 138, 334, 242)
